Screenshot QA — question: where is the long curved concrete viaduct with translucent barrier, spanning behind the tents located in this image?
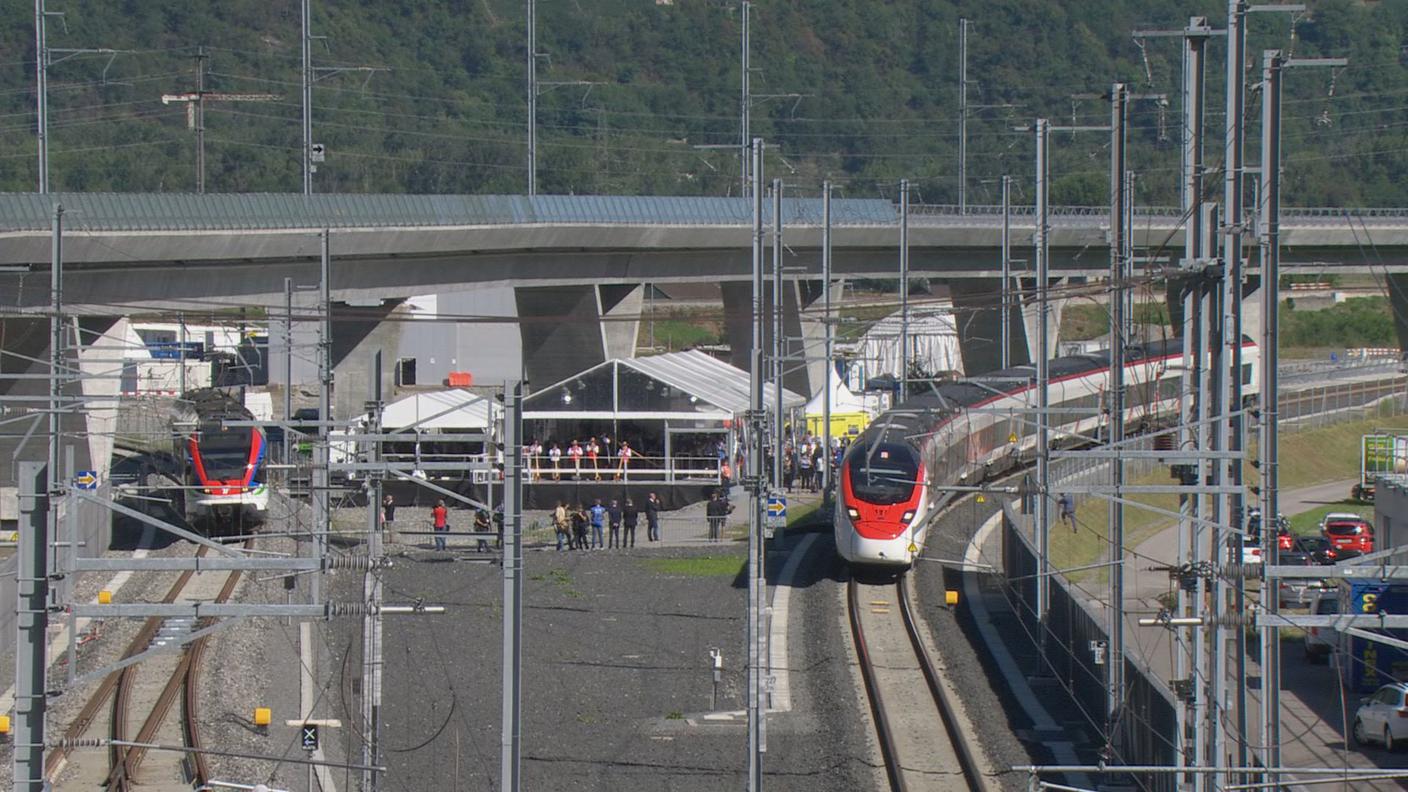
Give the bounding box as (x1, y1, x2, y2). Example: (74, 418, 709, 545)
(0, 193, 1408, 431)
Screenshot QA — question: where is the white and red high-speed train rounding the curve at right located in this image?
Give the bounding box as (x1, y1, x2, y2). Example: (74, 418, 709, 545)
(832, 340, 1260, 567)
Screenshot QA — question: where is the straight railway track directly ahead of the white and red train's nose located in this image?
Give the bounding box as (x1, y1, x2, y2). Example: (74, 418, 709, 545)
(846, 575, 988, 792)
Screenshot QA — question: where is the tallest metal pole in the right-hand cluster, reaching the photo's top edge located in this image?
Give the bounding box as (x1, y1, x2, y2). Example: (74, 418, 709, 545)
(1222, 0, 1267, 781)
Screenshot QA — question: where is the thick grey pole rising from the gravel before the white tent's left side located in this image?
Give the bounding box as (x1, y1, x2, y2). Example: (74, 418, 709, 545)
(498, 380, 524, 792)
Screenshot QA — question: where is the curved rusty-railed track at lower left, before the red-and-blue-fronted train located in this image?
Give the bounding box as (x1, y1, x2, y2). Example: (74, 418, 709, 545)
(45, 540, 253, 792)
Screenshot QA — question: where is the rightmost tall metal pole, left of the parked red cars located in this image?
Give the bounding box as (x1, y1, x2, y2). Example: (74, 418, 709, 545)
(1259, 49, 1286, 785)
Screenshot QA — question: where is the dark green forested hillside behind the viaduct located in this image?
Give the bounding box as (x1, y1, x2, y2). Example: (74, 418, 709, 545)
(0, 0, 1408, 206)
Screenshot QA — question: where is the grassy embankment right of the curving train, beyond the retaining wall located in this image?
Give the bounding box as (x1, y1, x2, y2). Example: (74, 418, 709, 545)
(1050, 416, 1408, 581)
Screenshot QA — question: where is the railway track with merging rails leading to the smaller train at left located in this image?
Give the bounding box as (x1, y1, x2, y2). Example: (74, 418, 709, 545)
(45, 540, 253, 792)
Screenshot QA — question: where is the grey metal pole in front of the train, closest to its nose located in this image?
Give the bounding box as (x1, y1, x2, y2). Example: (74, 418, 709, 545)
(1033, 118, 1050, 648)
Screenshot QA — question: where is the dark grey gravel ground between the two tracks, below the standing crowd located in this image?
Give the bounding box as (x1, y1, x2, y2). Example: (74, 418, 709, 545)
(383, 535, 870, 792)
